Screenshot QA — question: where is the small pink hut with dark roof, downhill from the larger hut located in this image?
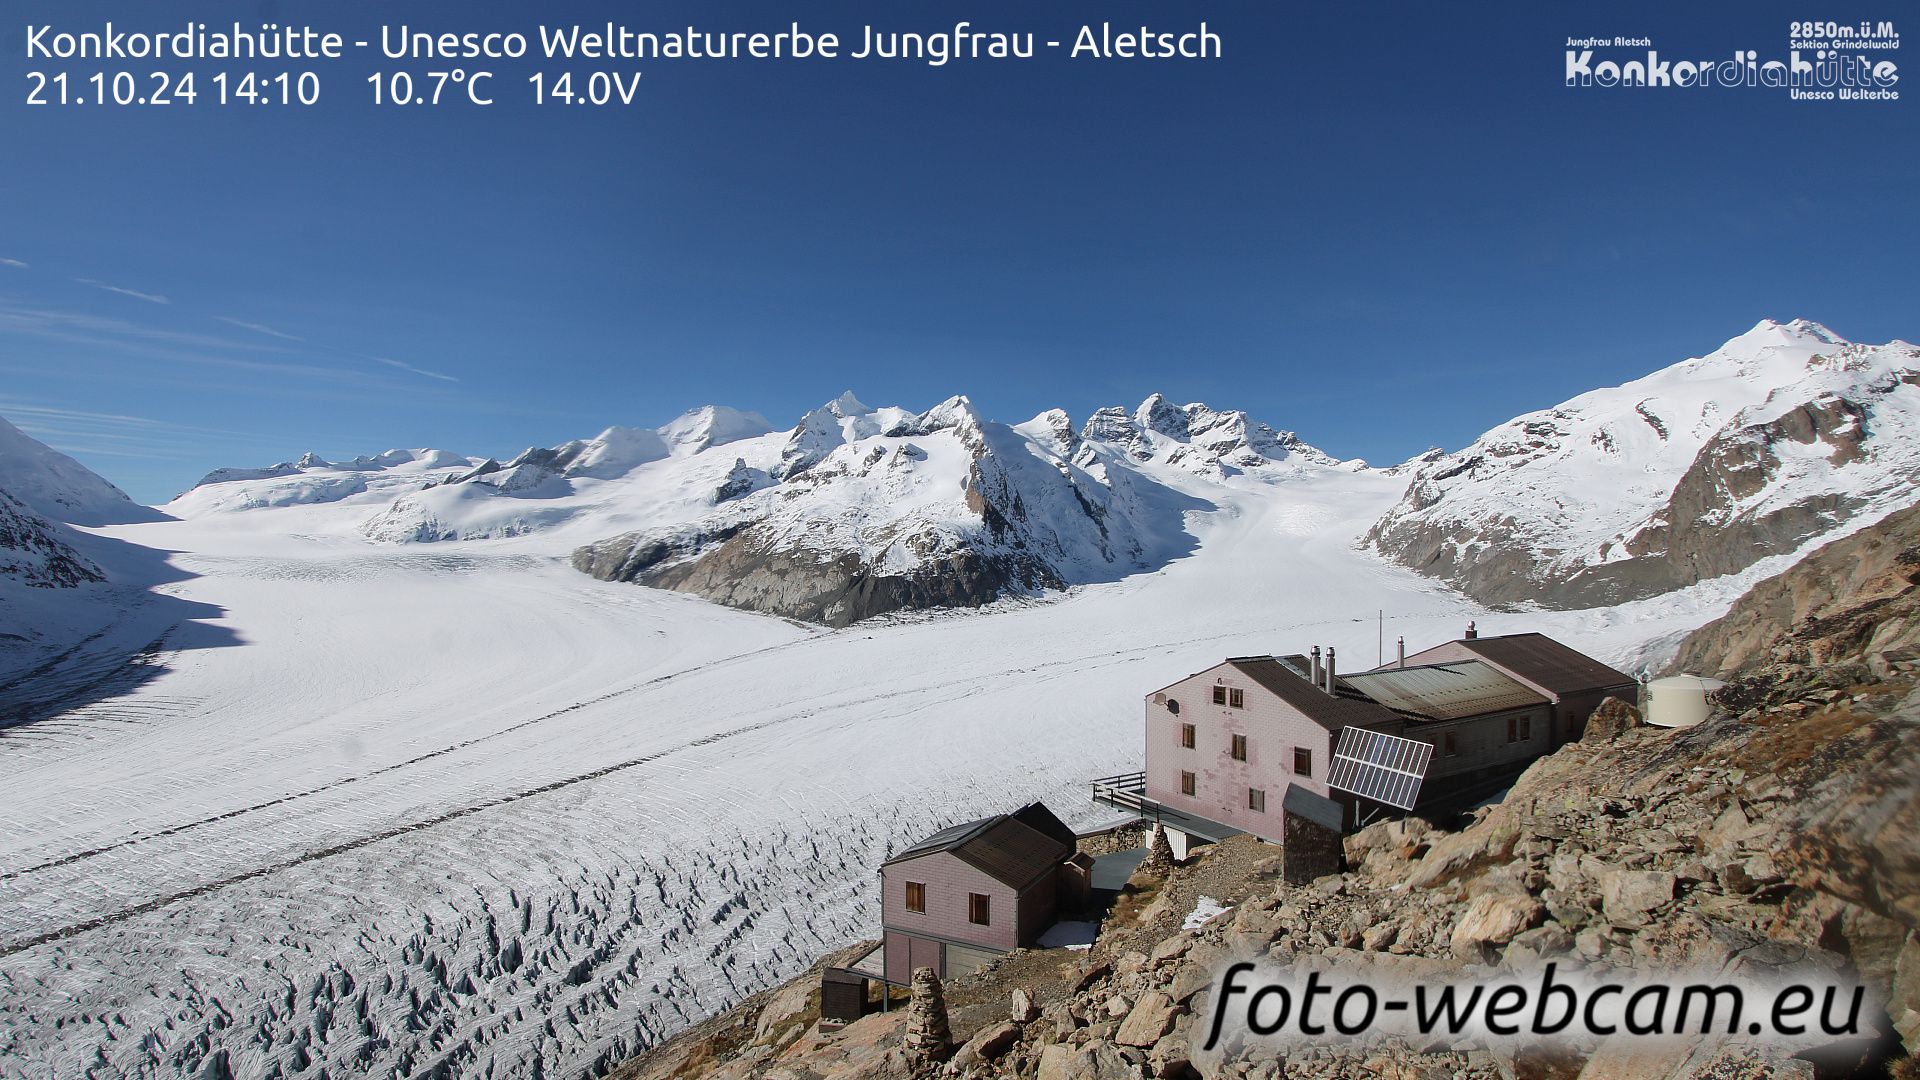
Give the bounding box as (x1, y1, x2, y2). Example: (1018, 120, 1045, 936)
(879, 803, 1091, 984)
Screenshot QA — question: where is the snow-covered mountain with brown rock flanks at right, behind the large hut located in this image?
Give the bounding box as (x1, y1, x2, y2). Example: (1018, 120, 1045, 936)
(1367, 319, 1920, 607)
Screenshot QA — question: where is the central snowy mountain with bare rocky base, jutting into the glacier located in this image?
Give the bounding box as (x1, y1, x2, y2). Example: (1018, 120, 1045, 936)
(574, 394, 1244, 626)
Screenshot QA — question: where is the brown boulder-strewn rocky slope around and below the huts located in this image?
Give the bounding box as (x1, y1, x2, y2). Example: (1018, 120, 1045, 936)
(618, 499, 1920, 1080)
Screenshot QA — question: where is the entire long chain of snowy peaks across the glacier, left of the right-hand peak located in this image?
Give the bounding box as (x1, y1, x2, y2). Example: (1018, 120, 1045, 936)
(167, 392, 1363, 625)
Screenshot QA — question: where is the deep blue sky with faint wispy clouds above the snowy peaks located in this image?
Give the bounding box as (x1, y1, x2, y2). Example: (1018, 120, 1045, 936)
(0, 0, 1920, 502)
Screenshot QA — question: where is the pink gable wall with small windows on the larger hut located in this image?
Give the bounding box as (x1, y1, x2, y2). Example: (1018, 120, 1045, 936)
(1146, 663, 1332, 842)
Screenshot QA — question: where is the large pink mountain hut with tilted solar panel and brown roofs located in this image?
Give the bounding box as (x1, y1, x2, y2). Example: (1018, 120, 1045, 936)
(1094, 625, 1640, 851)
